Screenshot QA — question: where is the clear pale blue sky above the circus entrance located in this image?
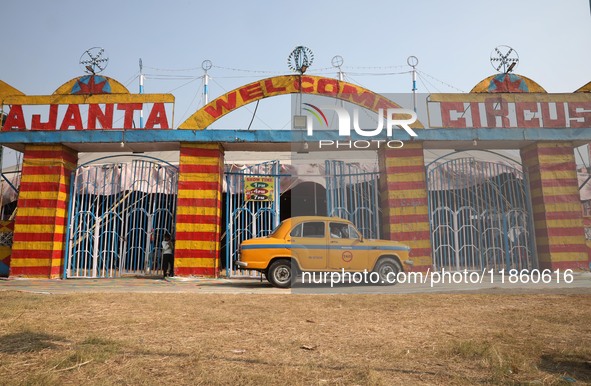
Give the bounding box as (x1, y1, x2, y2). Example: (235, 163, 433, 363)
(0, 0, 591, 166)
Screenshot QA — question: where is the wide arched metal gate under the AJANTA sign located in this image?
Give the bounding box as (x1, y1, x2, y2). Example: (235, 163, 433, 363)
(64, 156, 178, 278)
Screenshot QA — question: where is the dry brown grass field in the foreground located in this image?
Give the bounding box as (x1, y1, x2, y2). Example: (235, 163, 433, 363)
(0, 292, 591, 385)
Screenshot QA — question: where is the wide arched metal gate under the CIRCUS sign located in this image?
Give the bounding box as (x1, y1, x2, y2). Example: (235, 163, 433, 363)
(427, 158, 537, 271)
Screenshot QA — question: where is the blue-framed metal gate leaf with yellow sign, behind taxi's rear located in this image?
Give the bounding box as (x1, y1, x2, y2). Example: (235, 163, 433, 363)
(224, 161, 281, 277)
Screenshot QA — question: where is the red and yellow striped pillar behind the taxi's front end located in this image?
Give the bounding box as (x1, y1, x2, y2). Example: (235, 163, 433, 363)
(379, 142, 433, 271)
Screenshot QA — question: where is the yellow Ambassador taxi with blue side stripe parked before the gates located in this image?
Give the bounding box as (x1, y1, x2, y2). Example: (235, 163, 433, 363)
(236, 216, 412, 288)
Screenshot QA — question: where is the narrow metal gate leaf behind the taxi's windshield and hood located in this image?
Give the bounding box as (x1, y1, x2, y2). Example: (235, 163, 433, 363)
(325, 160, 380, 239)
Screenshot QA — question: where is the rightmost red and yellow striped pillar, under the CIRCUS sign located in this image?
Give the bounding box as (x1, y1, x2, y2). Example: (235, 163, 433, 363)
(521, 142, 589, 269)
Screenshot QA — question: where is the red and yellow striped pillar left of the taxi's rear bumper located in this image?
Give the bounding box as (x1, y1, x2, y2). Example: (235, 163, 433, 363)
(174, 143, 224, 276)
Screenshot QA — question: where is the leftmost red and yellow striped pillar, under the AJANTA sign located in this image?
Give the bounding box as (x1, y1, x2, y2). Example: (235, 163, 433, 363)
(10, 145, 78, 278)
